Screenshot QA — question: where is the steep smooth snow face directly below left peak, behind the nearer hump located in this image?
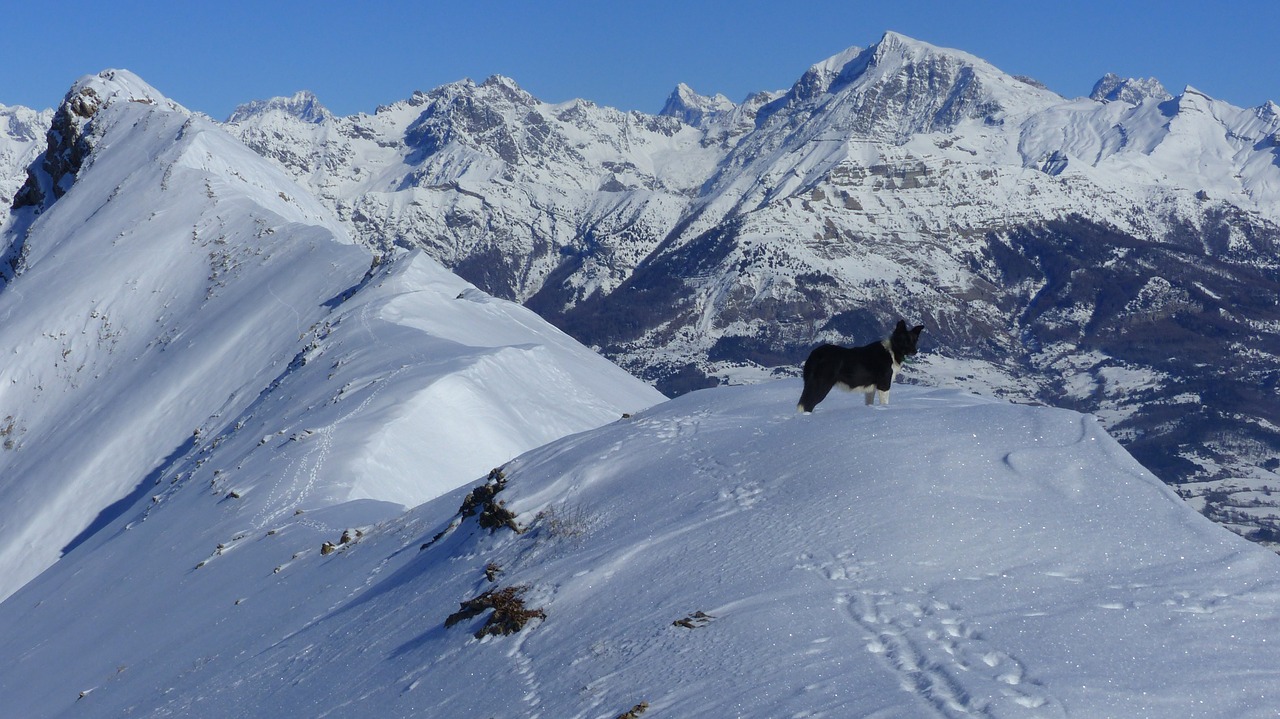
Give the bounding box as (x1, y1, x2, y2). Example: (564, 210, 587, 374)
(0, 73, 367, 594)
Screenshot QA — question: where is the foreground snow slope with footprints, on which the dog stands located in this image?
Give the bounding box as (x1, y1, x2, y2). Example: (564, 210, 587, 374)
(0, 380, 1280, 718)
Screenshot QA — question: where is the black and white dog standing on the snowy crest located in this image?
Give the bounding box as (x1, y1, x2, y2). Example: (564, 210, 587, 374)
(796, 320, 924, 415)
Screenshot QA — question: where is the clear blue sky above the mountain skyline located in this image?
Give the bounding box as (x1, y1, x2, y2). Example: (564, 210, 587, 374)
(0, 0, 1280, 119)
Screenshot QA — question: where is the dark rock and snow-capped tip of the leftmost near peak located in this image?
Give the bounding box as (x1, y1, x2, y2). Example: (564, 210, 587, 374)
(13, 70, 174, 210)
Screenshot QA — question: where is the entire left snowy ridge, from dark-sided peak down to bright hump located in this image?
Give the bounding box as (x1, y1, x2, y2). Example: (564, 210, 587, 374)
(0, 70, 662, 596)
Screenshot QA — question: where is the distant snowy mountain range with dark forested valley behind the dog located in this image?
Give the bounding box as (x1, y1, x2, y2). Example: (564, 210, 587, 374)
(228, 33, 1280, 540)
